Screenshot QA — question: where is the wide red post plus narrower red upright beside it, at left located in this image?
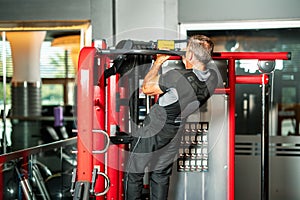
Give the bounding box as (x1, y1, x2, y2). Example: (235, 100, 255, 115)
(77, 44, 110, 200)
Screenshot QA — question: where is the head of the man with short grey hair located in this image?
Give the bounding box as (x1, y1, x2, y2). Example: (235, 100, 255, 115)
(186, 35, 214, 68)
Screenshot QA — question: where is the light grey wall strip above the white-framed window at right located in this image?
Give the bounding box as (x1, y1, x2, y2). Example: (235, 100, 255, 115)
(178, 0, 300, 23)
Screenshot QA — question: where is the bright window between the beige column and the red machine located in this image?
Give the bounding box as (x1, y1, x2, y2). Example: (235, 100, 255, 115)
(41, 42, 75, 105)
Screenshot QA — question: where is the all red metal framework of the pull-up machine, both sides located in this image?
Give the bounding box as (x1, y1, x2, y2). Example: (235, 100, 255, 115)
(77, 47, 290, 200)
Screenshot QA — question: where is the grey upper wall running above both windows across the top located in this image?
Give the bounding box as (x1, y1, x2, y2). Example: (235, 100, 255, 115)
(0, 0, 300, 40)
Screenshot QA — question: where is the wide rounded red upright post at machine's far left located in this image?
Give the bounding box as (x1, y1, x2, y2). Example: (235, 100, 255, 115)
(77, 47, 95, 181)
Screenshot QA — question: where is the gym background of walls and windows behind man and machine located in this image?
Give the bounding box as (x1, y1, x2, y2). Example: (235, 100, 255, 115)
(0, 0, 300, 200)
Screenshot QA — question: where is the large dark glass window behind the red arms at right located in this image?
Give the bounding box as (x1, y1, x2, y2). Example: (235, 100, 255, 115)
(187, 28, 300, 135)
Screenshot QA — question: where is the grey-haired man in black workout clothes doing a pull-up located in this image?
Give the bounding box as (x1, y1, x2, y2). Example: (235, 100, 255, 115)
(124, 35, 218, 200)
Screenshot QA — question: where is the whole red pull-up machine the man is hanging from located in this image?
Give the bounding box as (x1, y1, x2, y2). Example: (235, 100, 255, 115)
(72, 38, 291, 200)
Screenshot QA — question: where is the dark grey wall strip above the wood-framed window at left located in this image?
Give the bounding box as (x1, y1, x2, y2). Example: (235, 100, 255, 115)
(0, 0, 91, 21)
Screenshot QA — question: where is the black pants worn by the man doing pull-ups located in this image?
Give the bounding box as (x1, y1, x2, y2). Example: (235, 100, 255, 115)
(124, 127, 181, 200)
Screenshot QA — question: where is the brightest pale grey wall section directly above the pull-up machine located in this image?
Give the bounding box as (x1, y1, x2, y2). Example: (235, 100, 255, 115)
(99, 0, 177, 44)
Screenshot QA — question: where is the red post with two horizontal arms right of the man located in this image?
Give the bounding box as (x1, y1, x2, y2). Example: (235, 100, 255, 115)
(213, 52, 291, 200)
